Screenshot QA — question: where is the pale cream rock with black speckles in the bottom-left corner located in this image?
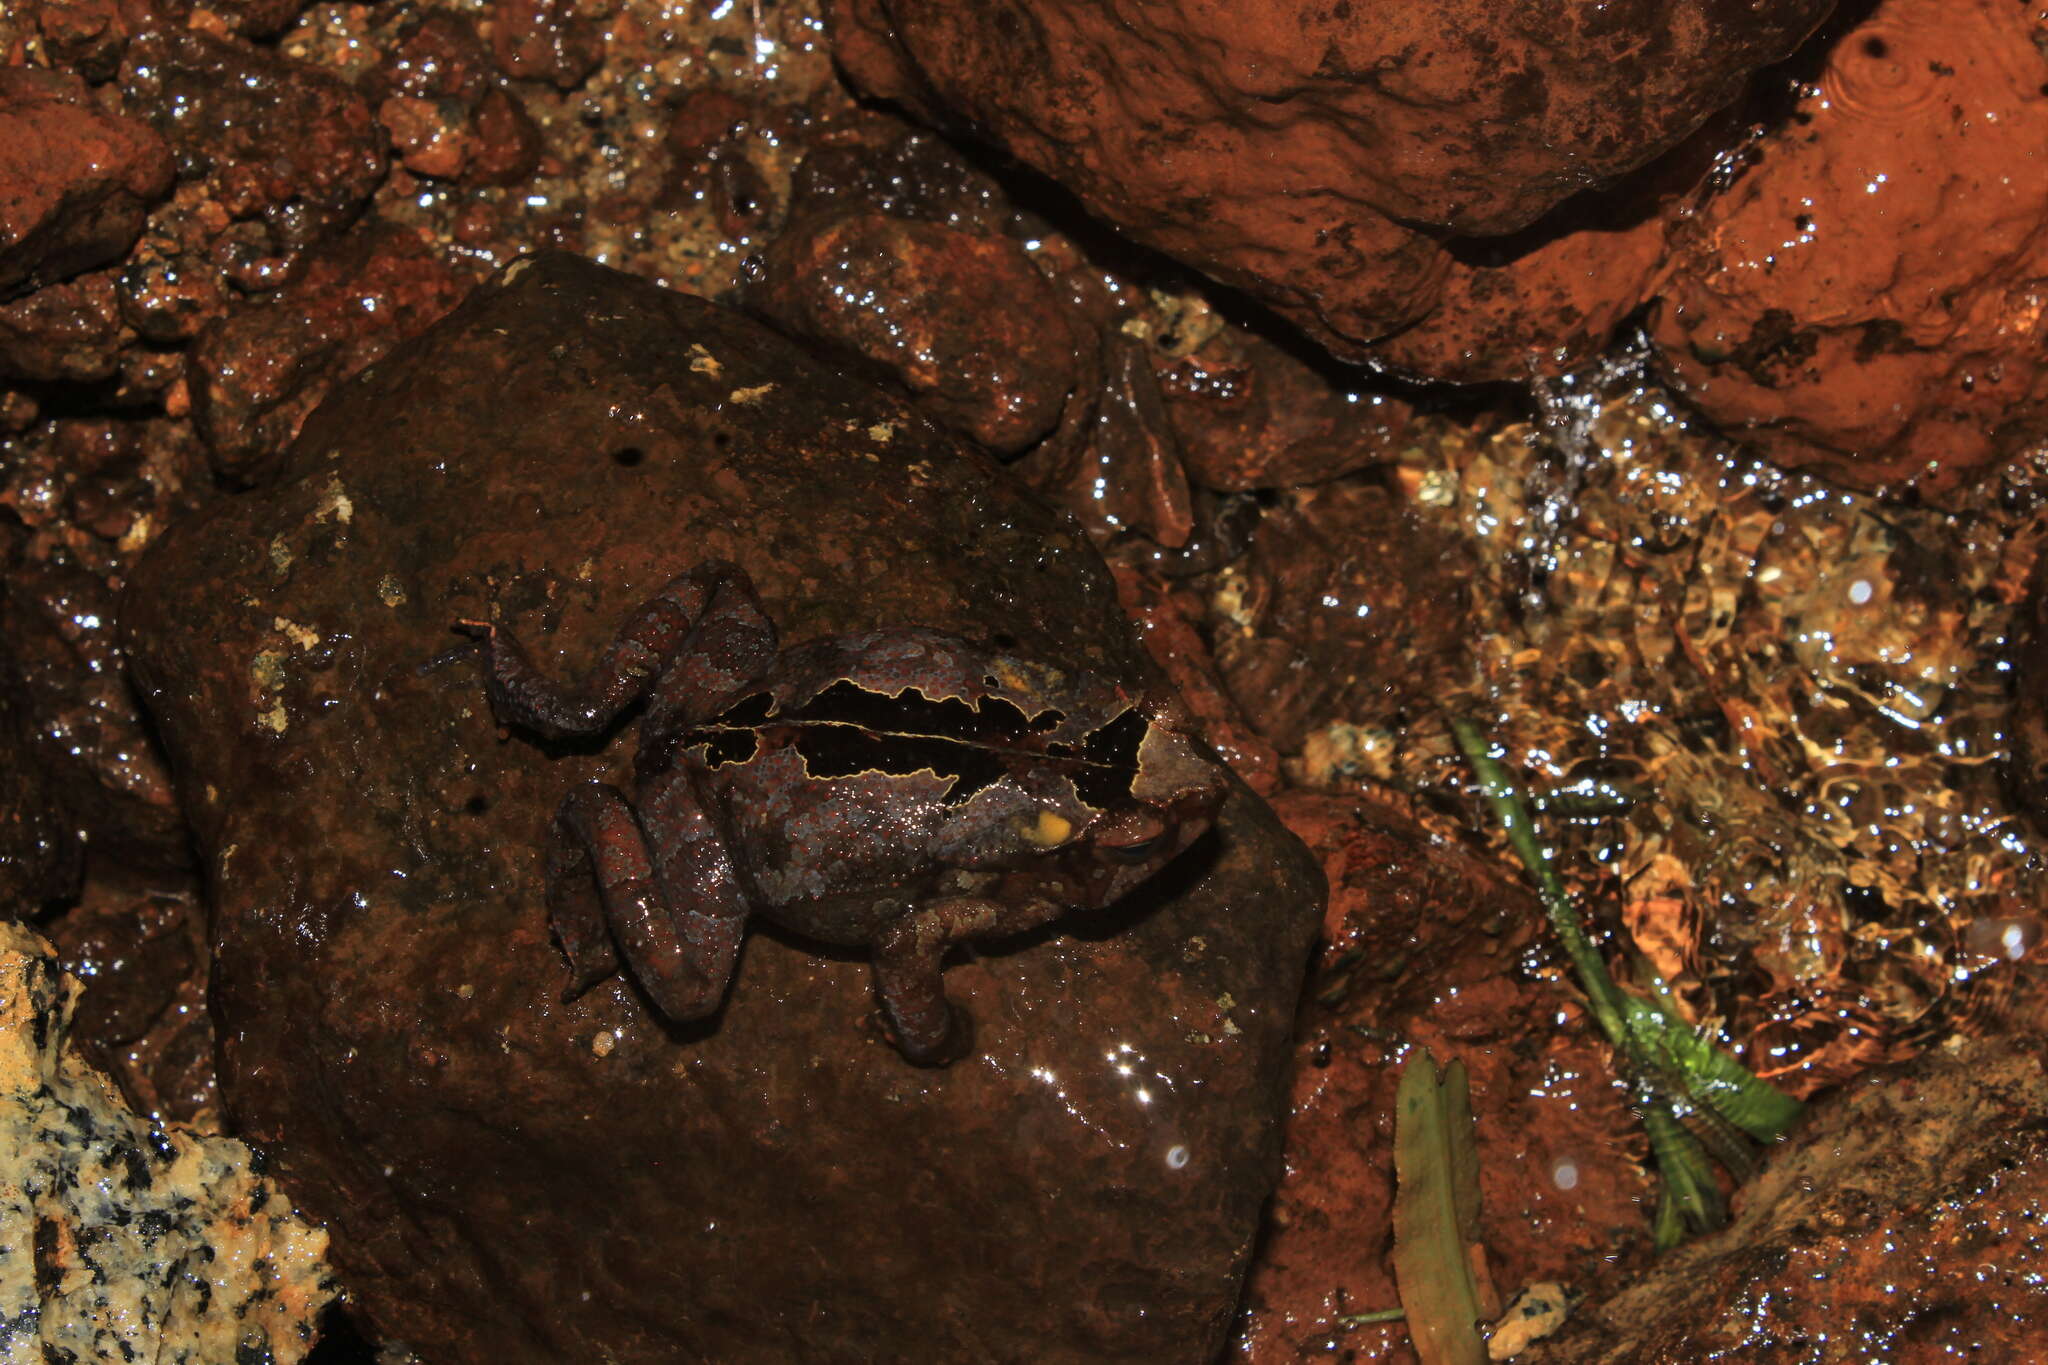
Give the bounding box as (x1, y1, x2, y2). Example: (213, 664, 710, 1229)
(0, 923, 334, 1365)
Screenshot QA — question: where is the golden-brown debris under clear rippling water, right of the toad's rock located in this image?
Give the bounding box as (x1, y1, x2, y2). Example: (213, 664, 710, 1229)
(1292, 349, 2040, 1097)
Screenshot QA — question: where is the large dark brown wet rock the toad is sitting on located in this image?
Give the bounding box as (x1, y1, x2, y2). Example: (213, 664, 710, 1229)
(125, 256, 1317, 1363)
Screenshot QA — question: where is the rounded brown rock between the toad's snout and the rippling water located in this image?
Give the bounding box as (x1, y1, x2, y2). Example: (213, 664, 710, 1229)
(1217, 481, 1475, 753)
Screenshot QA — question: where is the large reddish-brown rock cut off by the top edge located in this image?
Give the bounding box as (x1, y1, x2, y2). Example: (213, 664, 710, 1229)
(831, 0, 1831, 352)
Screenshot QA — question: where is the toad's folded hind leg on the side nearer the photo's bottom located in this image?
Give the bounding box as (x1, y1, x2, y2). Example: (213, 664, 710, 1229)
(547, 776, 745, 1023)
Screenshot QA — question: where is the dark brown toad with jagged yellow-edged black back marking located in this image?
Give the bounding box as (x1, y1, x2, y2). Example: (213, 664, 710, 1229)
(457, 561, 1225, 1066)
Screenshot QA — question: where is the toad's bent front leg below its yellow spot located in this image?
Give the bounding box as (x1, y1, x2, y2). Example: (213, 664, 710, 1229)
(874, 896, 1061, 1066)
